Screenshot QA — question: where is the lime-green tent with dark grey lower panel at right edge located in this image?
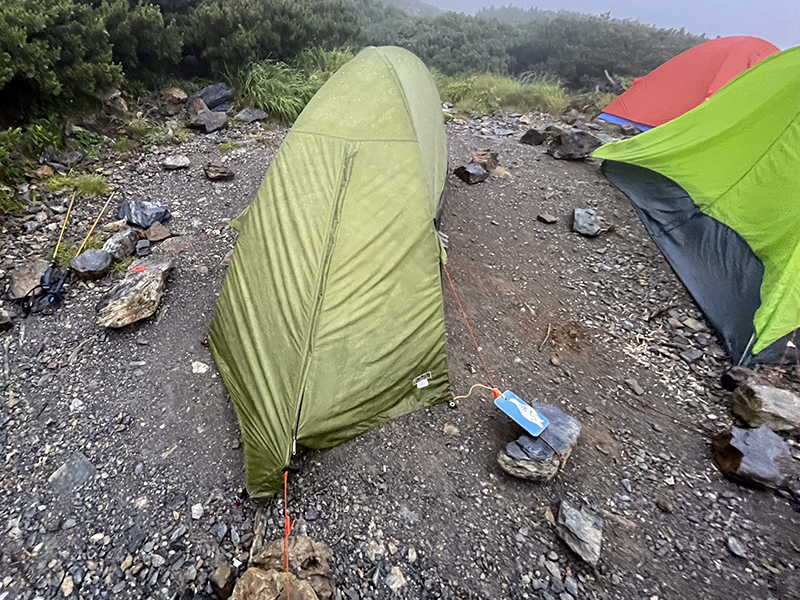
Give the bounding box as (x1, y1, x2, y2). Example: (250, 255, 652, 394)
(594, 48, 800, 363)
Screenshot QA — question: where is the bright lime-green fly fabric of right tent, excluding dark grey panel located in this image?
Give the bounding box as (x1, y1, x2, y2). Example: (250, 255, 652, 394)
(594, 48, 800, 353)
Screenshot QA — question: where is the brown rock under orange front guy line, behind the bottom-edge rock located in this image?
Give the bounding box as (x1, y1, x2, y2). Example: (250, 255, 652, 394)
(250, 535, 334, 598)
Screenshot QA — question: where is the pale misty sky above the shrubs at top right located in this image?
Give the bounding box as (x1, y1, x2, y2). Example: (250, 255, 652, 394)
(434, 0, 800, 49)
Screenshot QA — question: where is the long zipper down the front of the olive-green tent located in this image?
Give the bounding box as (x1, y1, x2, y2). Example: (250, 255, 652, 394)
(285, 141, 359, 464)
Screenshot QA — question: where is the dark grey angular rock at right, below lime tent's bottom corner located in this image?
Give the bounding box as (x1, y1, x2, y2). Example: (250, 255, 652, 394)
(712, 425, 791, 487)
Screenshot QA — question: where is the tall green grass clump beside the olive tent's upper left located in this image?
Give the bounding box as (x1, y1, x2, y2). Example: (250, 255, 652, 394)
(236, 61, 322, 123)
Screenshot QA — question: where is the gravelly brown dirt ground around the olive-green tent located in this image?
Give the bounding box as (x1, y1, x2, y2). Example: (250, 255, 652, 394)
(0, 117, 800, 600)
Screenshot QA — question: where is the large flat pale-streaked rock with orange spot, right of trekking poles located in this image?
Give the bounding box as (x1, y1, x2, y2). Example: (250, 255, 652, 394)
(97, 259, 172, 327)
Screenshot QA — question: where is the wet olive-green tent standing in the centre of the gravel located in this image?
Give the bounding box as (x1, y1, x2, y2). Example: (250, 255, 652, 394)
(209, 47, 450, 496)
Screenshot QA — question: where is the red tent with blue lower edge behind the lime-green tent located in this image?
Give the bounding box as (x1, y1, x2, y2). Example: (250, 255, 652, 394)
(599, 36, 779, 130)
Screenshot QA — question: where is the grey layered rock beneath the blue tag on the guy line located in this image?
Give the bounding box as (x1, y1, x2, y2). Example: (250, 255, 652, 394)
(497, 402, 581, 481)
